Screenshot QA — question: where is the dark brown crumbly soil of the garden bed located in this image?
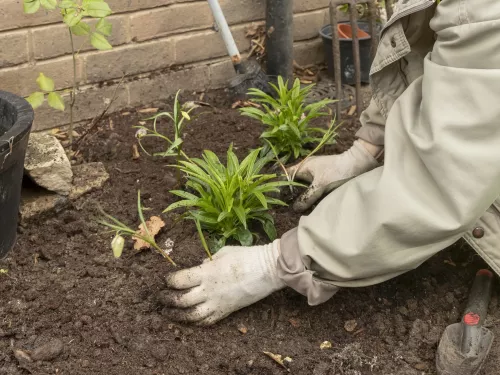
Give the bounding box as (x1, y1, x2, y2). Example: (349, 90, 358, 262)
(0, 87, 500, 375)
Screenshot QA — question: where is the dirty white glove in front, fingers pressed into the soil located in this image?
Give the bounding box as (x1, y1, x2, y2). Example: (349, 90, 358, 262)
(159, 240, 285, 325)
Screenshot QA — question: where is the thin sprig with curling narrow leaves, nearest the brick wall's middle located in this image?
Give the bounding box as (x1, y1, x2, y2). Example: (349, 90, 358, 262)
(135, 90, 194, 184)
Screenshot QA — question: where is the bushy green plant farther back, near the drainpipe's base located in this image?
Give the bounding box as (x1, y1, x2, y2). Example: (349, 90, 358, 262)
(240, 77, 335, 164)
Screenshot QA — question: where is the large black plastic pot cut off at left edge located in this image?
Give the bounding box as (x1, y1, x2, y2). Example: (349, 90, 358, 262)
(0, 91, 33, 258)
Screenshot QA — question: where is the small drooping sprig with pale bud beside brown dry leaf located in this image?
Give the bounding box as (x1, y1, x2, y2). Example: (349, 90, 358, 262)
(98, 191, 176, 266)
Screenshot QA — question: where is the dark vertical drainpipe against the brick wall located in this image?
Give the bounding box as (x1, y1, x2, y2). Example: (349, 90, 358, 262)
(266, 0, 293, 81)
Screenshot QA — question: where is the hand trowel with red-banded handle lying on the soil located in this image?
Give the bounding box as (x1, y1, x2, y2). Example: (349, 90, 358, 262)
(436, 269, 493, 375)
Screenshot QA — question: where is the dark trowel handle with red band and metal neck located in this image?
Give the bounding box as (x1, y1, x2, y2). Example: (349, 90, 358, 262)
(461, 269, 493, 355)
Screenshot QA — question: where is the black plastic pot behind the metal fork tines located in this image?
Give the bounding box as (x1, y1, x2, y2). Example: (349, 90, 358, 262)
(319, 21, 381, 85)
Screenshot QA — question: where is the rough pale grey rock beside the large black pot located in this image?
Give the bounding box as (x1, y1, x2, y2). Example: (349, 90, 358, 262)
(24, 133, 73, 195)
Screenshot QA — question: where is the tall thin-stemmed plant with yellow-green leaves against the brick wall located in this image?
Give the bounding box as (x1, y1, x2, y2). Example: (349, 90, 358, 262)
(23, 0, 112, 144)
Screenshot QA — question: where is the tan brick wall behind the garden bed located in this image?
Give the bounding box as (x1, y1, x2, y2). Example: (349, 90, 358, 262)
(0, 0, 329, 130)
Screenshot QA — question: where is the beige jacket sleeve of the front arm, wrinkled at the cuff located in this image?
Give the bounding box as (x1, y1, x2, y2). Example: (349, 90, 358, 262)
(278, 0, 500, 305)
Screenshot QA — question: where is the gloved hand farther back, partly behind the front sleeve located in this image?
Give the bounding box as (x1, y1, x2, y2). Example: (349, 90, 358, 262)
(288, 140, 383, 212)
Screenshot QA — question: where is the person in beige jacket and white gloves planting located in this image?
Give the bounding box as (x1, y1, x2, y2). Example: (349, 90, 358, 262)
(162, 0, 500, 325)
